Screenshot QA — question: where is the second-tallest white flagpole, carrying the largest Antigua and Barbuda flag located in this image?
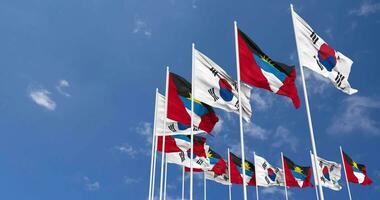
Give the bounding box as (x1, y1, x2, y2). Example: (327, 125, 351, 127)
(234, 21, 247, 200)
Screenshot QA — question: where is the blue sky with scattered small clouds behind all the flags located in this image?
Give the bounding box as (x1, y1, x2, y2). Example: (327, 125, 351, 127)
(0, 0, 380, 200)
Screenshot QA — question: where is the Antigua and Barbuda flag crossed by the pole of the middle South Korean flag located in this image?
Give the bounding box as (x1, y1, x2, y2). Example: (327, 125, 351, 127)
(167, 73, 219, 133)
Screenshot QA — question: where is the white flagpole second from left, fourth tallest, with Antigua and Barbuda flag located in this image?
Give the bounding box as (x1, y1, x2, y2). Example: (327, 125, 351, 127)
(159, 67, 169, 200)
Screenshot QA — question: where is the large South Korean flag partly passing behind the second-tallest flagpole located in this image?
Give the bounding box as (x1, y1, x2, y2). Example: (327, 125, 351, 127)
(193, 49, 252, 121)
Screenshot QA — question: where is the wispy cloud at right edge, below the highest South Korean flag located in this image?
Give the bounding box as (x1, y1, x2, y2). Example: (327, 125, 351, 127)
(327, 96, 380, 135)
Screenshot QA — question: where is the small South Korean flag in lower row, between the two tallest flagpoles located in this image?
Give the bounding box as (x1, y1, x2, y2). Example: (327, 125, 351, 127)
(254, 155, 284, 187)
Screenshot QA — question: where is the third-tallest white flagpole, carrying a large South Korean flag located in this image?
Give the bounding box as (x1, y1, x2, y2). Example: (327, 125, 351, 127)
(190, 43, 195, 200)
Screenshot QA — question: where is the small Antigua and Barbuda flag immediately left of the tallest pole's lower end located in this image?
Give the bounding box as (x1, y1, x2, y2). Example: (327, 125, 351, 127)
(283, 156, 313, 188)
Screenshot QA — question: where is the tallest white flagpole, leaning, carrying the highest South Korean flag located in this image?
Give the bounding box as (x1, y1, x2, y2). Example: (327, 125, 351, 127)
(290, 4, 325, 200)
